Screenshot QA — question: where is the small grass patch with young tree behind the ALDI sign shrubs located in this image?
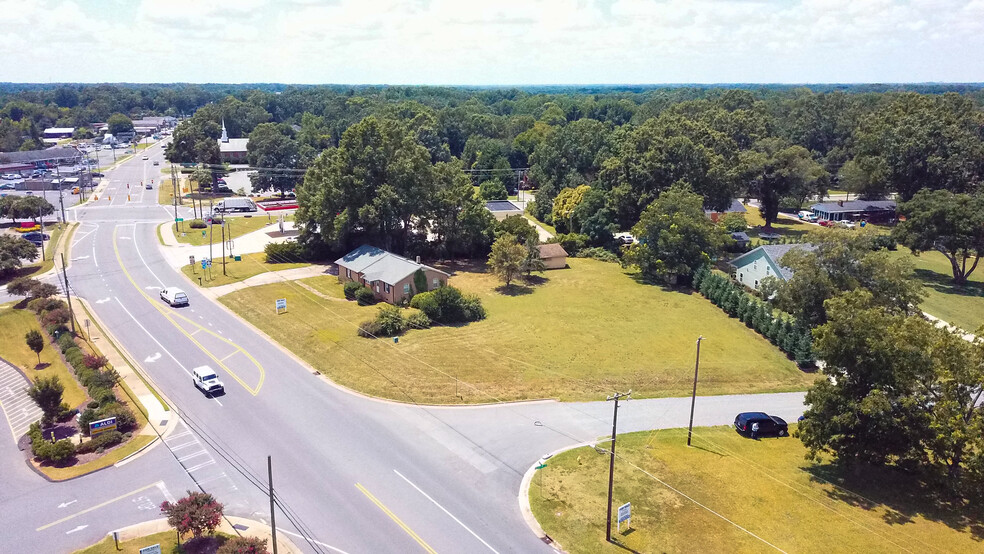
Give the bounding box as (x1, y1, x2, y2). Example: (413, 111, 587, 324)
(0, 304, 87, 408)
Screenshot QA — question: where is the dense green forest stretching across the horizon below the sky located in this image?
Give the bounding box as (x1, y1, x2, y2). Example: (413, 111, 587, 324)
(0, 84, 984, 254)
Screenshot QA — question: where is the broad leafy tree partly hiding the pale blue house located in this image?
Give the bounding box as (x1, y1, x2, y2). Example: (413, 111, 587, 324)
(763, 229, 922, 327)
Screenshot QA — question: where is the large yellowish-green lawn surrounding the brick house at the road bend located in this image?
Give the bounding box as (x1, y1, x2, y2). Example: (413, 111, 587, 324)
(220, 254, 813, 404)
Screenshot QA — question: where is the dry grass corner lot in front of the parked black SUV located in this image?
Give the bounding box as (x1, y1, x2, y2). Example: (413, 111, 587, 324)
(529, 427, 984, 553)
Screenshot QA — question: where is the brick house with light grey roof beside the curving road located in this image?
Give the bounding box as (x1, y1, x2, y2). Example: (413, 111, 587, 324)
(335, 244, 449, 304)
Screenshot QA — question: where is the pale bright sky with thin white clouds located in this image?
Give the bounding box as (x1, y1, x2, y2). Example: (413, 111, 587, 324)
(0, 0, 984, 85)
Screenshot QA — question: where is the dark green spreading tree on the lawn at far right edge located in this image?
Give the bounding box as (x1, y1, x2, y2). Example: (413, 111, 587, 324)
(893, 190, 984, 284)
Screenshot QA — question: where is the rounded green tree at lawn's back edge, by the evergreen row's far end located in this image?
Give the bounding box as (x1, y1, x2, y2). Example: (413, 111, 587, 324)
(632, 183, 724, 283)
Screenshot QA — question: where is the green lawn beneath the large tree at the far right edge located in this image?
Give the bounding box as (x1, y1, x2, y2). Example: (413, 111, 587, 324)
(897, 246, 984, 333)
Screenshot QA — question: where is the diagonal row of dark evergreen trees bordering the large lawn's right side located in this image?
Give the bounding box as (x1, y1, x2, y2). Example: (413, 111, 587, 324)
(693, 266, 816, 367)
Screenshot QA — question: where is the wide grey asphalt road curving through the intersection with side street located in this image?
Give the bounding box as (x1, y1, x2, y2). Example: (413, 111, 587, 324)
(0, 146, 803, 553)
